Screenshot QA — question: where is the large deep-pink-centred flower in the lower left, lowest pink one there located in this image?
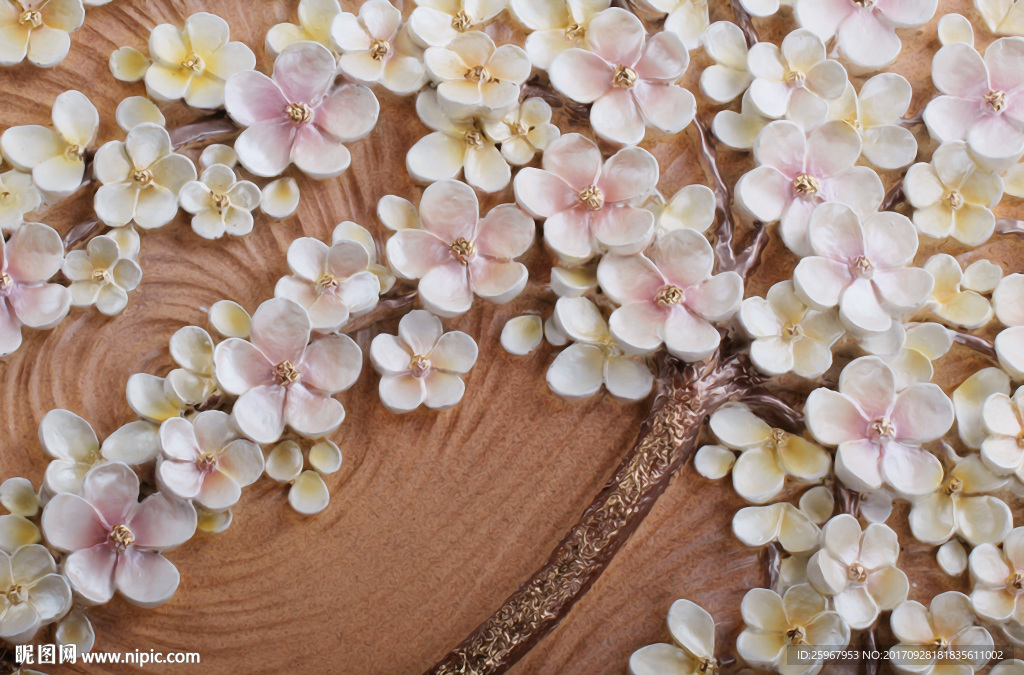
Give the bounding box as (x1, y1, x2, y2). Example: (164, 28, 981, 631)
(42, 462, 197, 607)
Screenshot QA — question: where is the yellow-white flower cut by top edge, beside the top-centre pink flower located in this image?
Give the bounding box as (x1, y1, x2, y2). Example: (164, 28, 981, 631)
(509, 0, 611, 71)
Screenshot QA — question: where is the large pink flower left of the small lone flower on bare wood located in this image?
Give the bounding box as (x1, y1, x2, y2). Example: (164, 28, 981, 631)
(213, 298, 362, 442)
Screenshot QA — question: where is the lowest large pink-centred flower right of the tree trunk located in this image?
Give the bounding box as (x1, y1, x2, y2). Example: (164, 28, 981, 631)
(804, 356, 953, 495)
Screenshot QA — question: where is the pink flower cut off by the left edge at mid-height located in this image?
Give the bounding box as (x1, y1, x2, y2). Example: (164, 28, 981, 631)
(0, 222, 71, 356)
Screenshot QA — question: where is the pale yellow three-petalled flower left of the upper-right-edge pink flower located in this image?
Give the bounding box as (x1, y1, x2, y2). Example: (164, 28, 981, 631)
(828, 73, 918, 169)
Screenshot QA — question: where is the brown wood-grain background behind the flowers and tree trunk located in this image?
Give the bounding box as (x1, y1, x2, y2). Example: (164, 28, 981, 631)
(0, 0, 1024, 674)
